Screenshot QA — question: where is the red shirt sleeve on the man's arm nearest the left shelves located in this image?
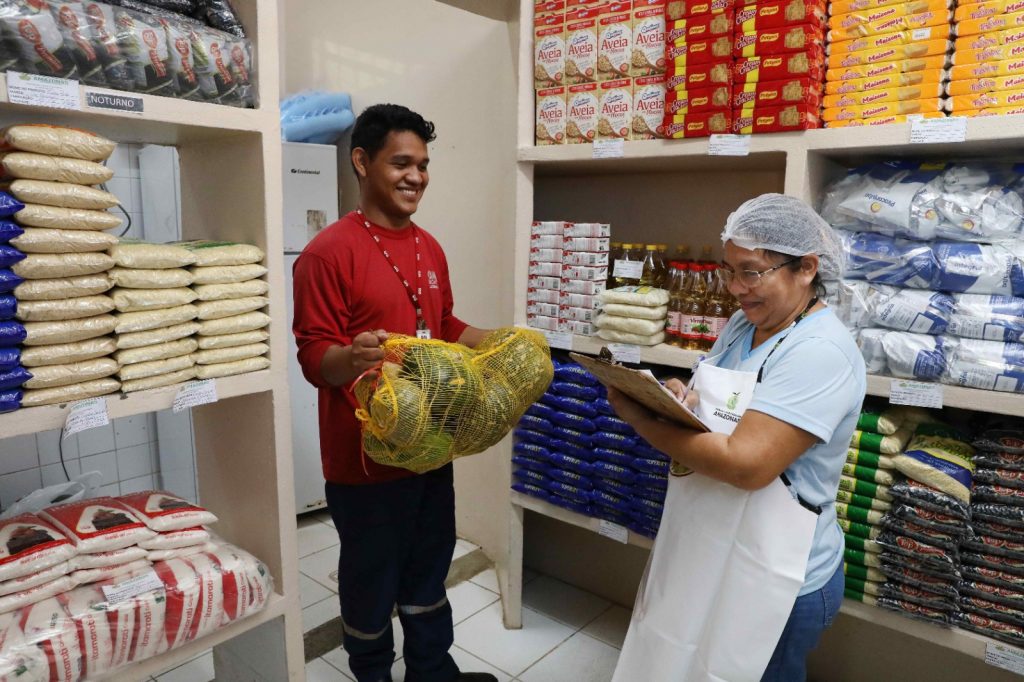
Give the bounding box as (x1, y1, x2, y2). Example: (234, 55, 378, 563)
(292, 254, 352, 388)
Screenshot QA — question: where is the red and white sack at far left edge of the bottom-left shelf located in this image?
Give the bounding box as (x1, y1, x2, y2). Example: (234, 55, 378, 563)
(0, 514, 76, 581)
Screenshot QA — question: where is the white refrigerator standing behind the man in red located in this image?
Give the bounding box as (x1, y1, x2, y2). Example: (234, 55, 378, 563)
(282, 142, 341, 514)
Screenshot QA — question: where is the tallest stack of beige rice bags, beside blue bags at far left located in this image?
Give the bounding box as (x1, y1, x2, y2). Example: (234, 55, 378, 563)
(0, 125, 121, 407)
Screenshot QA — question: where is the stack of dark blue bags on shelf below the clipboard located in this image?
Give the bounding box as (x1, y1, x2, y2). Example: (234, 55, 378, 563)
(512, 360, 669, 538)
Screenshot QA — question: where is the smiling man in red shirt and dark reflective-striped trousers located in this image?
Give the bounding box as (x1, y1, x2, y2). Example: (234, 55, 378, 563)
(293, 104, 497, 682)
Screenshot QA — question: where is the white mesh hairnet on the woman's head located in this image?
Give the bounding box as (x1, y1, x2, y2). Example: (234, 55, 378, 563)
(722, 194, 843, 280)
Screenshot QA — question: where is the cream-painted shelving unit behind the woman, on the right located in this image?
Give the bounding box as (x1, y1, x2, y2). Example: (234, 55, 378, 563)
(498, 1, 1024, 680)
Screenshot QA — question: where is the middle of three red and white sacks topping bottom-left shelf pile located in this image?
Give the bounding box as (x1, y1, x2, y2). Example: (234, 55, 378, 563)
(40, 498, 154, 554)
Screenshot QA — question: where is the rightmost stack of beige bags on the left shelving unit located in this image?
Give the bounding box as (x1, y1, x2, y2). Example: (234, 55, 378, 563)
(186, 241, 270, 379)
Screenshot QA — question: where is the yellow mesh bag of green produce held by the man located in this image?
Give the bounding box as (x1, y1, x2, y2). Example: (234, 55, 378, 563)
(354, 327, 554, 473)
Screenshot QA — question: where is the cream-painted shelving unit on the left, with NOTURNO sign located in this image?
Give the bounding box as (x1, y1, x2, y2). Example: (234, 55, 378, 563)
(0, 0, 304, 682)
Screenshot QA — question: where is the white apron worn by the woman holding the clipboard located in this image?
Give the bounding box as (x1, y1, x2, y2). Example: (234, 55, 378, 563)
(612, 352, 817, 682)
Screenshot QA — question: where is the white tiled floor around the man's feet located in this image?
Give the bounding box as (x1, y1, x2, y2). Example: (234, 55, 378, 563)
(148, 514, 630, 682)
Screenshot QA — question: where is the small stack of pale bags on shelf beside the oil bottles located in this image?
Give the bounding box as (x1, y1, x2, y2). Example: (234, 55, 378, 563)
(595, 287, 669, 346)
